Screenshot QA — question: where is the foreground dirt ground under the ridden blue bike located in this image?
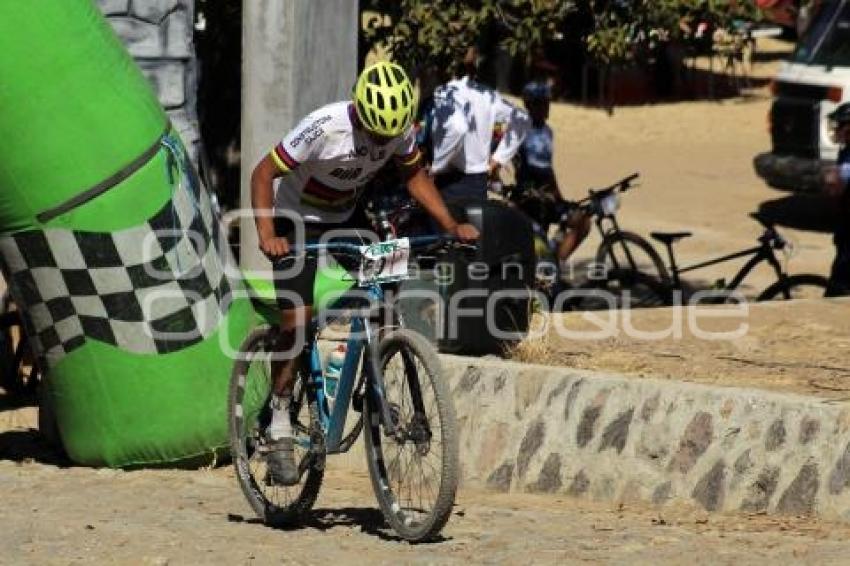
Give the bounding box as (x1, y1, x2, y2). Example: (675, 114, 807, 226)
(0, 454, 850, 565)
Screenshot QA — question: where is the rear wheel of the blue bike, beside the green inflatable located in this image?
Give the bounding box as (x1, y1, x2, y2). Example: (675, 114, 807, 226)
(228, 326, 324, 526)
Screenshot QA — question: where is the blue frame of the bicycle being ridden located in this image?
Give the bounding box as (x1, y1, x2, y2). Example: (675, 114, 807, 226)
(296, 236, 440, 454)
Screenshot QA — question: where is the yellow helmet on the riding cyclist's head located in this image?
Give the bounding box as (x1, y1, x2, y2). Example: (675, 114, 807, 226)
(353, 61, 416, 137)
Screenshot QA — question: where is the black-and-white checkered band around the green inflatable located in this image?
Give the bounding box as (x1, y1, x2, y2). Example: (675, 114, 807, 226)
(0, 178, 232, 368)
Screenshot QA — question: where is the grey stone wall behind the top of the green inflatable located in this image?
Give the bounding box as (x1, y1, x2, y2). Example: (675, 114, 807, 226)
(97, 0, 200, 163)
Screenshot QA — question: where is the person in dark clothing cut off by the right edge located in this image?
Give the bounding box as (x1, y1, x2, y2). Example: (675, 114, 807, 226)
(826, 102, 850, 297)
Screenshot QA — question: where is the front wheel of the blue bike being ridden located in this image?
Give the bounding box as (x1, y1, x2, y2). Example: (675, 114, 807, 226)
(365, 330, 459, 542)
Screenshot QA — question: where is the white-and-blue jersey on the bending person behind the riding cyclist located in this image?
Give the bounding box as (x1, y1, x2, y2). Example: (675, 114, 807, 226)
(431, 77, 529, 174)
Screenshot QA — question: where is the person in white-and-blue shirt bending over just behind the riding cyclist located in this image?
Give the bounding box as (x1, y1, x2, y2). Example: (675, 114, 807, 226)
(431, 50, 529, 200)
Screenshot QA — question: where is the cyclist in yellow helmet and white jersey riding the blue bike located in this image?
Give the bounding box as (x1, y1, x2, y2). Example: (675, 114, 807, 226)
(251, 62, 478, 485)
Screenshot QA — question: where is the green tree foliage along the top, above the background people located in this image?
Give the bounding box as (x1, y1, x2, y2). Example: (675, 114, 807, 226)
(361, 0, 758, 69)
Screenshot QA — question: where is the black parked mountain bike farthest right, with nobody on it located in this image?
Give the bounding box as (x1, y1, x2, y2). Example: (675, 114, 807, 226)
(650, 213, 827, 304)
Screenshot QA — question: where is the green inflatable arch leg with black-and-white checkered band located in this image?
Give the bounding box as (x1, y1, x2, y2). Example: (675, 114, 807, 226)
(0, 0, 266, 467)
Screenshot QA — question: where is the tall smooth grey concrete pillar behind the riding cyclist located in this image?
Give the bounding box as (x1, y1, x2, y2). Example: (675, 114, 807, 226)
(240, 0, 358, 269)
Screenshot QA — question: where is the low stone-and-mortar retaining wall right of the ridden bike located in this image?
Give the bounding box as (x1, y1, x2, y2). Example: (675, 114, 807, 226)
(332, 356, 850, 520)
